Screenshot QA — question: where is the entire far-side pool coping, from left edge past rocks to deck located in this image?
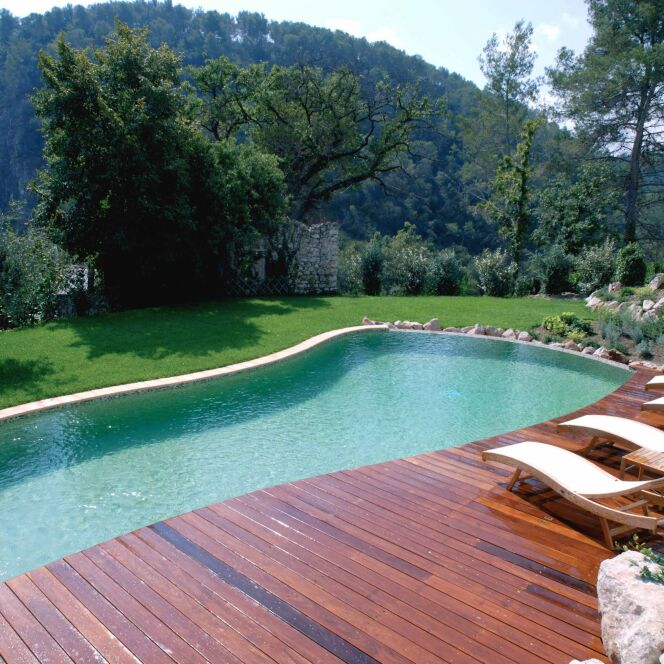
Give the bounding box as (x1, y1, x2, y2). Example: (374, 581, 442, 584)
(0, 324, 633, 422)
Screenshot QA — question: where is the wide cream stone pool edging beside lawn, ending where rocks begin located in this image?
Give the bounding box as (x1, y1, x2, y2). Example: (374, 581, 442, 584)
(0, 325, 388, 422)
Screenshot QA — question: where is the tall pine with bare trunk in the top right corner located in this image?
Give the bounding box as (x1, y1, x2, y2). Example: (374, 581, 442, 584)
(548, 0, 664, 244)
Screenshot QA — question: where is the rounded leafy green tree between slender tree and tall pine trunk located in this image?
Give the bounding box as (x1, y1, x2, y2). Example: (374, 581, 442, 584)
(533, 165, 617, 256)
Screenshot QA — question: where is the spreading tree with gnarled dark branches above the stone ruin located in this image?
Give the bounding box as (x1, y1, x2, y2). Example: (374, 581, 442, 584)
(192, 58, 435, 221)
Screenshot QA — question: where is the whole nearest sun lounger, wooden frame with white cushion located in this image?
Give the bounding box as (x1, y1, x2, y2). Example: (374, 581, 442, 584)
(482, 442, 664, 548)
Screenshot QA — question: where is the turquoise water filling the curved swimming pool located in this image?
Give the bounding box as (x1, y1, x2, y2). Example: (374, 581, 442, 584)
(0, 332, 630, 579)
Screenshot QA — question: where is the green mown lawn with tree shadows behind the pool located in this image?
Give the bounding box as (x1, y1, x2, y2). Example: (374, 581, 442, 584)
(0, 297, 590, 408)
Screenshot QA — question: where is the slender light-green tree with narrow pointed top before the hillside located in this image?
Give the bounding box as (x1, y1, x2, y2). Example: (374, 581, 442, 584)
(484, 119, 542, 274)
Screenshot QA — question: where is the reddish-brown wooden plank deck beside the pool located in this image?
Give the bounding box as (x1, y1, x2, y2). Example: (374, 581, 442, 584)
(0, 372, 664, 664)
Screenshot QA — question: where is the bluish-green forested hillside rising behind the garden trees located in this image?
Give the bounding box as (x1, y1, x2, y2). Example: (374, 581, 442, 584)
(0, 2, 570, 253)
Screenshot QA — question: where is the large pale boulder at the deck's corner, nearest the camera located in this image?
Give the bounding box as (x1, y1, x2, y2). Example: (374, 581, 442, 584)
(597, 551, 664, 664)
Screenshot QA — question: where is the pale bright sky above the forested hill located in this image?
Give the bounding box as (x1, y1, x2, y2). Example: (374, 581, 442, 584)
(0, 0, 591, 87)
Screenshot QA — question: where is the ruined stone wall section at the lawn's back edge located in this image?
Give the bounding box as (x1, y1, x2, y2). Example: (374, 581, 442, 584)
(293, 223, 339, 295)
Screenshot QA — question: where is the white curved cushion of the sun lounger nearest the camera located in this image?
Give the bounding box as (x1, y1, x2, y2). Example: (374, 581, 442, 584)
(485, 441, 664, 498)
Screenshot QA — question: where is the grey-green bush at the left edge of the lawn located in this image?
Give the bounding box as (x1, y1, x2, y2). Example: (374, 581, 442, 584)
(0, 224, 69, 327)
